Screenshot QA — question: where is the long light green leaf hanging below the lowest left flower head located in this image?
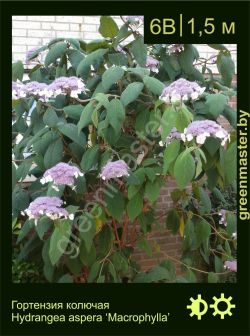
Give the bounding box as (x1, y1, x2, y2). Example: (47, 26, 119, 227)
(49, 219, 73, 265)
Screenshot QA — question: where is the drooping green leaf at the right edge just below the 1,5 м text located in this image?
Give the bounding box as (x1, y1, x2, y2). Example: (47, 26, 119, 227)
(217, 51, 235, 87)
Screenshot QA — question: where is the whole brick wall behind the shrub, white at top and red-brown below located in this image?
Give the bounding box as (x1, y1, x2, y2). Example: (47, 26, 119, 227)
(12, 16, 236, 273)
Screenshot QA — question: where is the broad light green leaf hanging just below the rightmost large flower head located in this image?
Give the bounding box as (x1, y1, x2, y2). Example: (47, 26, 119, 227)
(174, 151, 195, 189)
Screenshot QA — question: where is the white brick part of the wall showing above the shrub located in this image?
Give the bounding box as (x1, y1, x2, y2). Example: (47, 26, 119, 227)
(12, 15, 236, 68)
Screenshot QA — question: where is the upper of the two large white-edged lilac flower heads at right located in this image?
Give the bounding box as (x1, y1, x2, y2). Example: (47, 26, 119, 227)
(160, 78, 205, 103)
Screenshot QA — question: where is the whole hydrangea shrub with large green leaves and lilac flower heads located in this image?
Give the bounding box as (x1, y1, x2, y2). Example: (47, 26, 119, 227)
(12, 16, 237, 283)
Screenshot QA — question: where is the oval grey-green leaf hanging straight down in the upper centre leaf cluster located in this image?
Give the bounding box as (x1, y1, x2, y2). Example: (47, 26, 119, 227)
(107, 99, 125, 133)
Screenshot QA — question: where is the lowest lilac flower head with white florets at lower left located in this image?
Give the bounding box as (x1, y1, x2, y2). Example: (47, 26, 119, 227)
(23, 196, 74, 223)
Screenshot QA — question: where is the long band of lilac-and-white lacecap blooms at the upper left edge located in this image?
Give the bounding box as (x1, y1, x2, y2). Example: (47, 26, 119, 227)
(12, 76, 87, 102)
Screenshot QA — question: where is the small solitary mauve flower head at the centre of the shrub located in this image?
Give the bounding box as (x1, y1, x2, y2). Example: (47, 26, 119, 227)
(100, 160, 129, 180)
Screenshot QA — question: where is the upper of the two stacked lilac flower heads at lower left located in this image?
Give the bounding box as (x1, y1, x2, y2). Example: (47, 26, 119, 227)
(41, 162, 83, 186)
